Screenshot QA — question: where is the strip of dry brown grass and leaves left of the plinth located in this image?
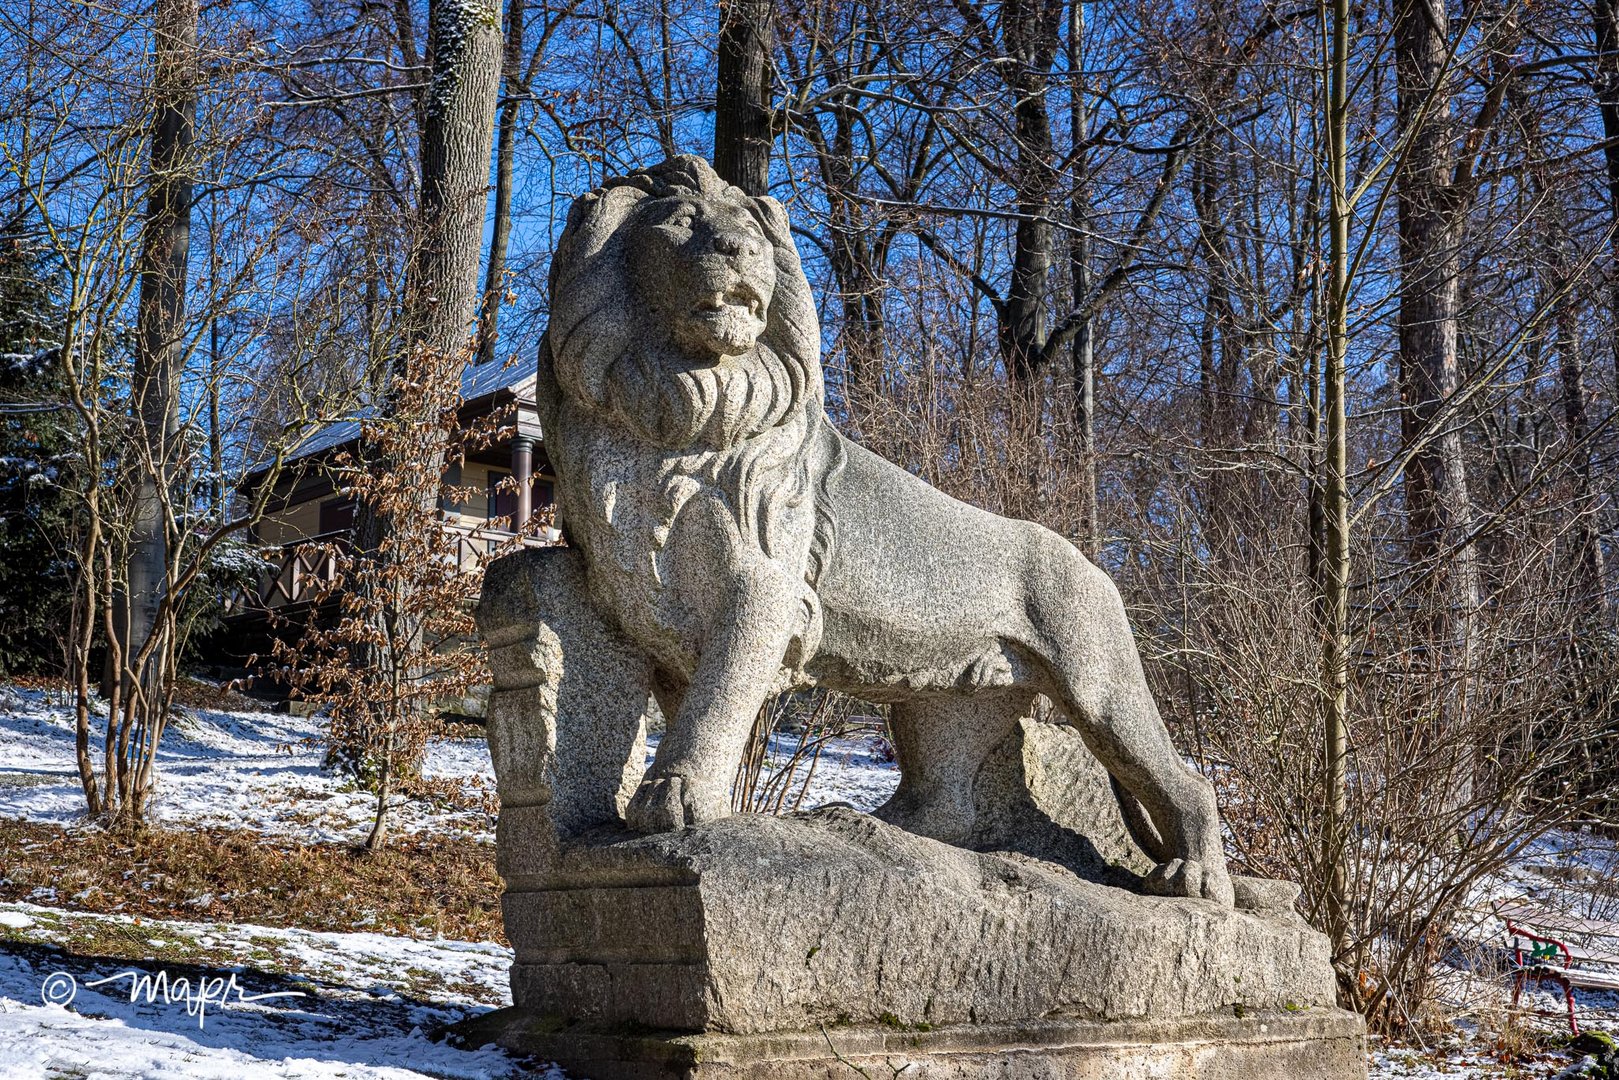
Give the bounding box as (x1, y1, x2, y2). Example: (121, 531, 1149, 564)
(0, 821, 505, 942)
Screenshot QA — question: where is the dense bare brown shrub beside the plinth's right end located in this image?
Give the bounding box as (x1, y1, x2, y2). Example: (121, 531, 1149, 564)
(1159, 524, 1619, 1030)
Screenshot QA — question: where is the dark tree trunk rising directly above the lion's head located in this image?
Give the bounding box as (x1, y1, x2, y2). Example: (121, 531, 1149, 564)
(714, 0, 774, 196)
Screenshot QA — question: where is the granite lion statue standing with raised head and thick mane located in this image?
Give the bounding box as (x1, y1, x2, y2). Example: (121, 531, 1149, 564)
(479, 157, 1232, 907)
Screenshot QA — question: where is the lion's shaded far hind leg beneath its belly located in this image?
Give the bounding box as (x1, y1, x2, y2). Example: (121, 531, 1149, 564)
(876, 690, 1035, 844)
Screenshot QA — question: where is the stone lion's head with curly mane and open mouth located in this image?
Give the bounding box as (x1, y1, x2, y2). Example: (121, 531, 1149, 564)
(547, 157, 822, 449)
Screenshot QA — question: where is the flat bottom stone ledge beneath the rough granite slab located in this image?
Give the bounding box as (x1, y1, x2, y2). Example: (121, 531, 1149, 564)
(457, 1009, 1366, 1080)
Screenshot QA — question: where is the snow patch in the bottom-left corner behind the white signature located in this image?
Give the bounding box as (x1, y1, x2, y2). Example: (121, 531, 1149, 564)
(0, 904, 547, 1080)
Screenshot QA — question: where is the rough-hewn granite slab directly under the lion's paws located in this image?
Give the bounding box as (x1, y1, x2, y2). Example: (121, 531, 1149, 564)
(504, 808, 1334, 1035)
